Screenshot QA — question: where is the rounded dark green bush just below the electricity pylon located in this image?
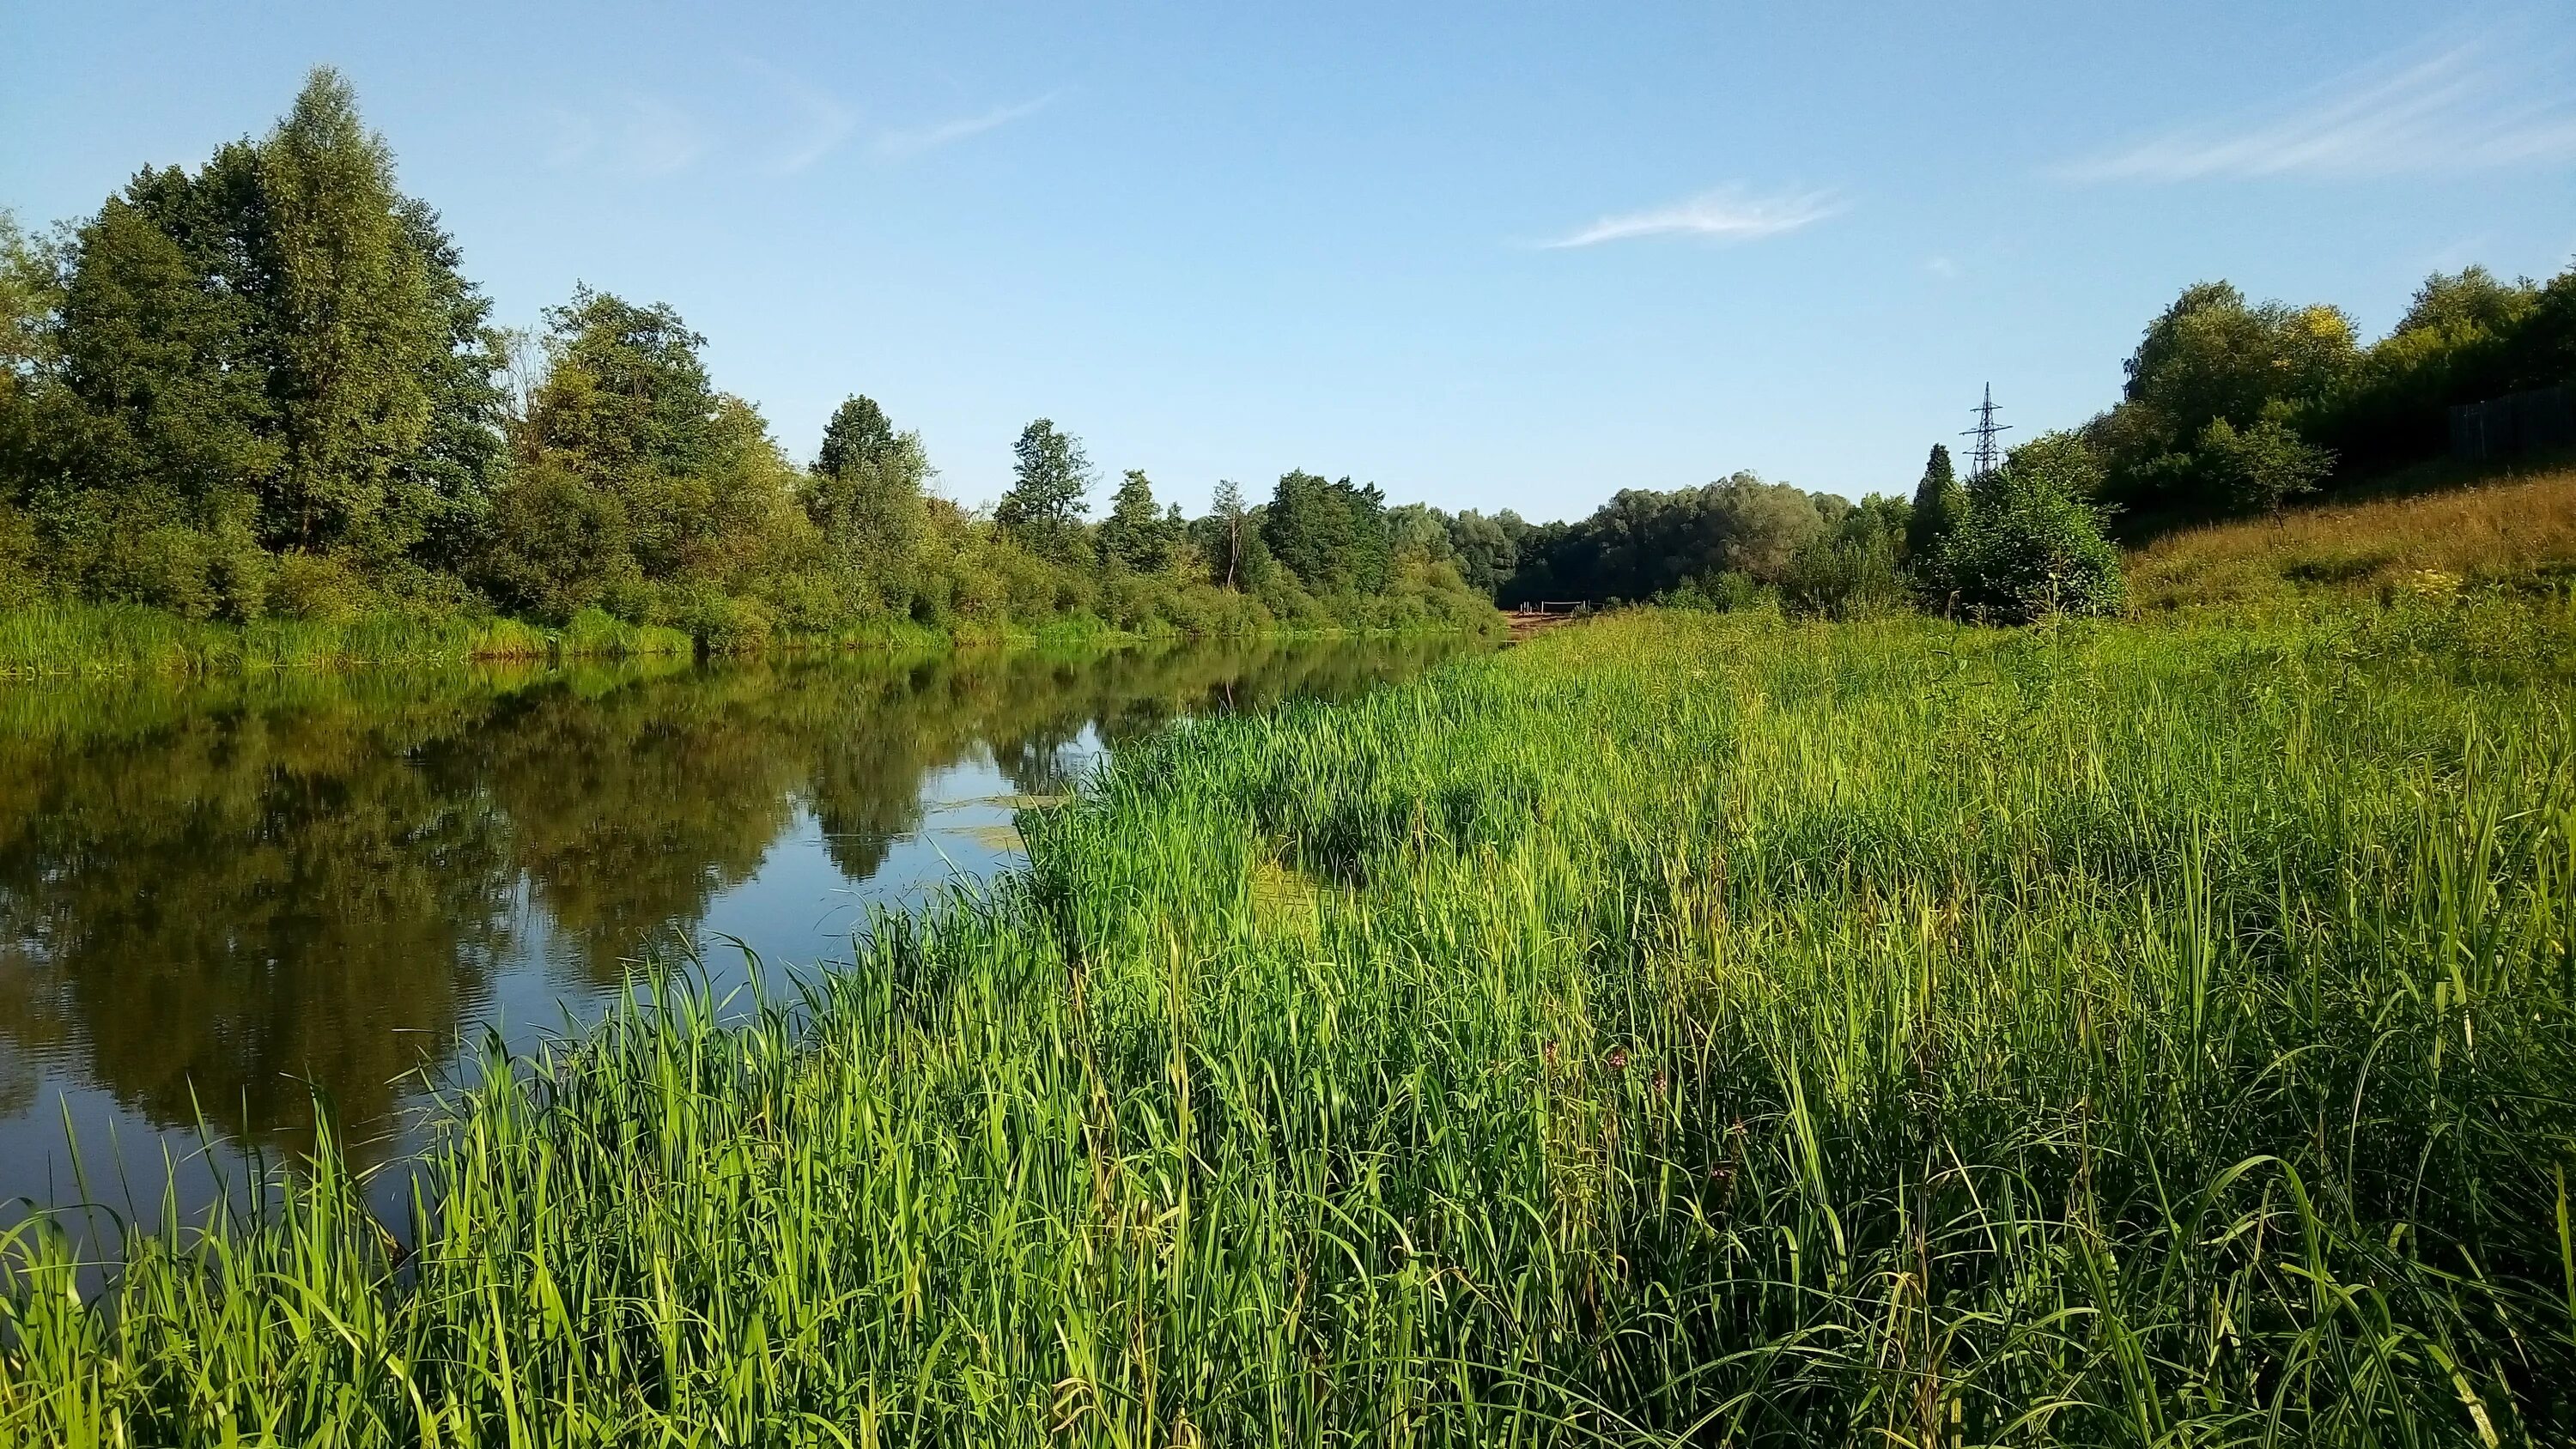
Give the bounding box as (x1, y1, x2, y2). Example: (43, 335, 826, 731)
(1919, 433, 2128, 623)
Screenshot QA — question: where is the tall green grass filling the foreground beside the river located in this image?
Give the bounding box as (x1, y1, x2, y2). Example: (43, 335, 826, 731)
(0, 615, 2576, 1449)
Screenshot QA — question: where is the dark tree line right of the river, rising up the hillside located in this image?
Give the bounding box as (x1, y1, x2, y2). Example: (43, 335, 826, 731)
(1437, 265, 2576, 623)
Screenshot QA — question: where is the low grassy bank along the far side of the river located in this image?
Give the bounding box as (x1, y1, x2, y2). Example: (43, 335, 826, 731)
(0, 591, 1504, 680)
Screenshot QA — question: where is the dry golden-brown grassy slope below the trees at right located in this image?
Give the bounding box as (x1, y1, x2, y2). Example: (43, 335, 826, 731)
(2130, 466, 2576, 610)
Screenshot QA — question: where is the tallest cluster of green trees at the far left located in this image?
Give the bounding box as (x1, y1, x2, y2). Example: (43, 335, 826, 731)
(5, 72, 497, 618)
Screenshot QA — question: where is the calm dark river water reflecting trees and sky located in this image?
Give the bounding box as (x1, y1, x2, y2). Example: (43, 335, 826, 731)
(0, 641, 1455, 1220)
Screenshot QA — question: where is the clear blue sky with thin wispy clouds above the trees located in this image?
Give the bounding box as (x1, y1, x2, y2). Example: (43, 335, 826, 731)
(0, 0, 2576, 518)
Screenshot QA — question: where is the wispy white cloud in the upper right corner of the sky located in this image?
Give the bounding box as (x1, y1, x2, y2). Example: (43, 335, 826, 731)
(2058, 44, 2576, 180)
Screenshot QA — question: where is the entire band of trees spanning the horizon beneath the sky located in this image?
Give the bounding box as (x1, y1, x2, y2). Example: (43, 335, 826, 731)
(0, 70, 2576, 649)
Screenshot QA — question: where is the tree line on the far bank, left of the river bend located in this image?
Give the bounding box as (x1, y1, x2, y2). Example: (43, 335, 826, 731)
(0, 70, 1489, 649)
